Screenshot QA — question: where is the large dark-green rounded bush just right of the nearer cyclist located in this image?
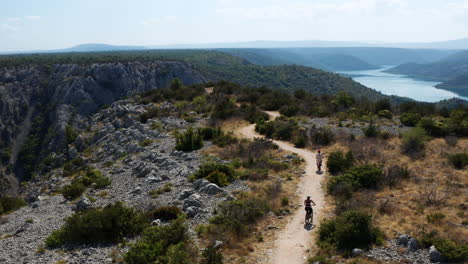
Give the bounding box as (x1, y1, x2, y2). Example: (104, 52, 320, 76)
(318, 211, 382, 252)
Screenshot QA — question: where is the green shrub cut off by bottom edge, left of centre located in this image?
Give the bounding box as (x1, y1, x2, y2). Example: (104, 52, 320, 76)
(124, 220, 192, 264)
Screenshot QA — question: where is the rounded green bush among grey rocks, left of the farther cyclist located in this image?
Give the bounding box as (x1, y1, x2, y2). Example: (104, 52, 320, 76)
(191, 162, 236, 187)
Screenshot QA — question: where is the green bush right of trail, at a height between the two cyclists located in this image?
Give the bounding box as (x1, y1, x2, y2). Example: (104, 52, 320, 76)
(328, 164, 383, 193)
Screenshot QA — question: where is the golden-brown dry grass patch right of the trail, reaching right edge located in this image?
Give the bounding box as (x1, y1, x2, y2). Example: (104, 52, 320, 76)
(328, 138, 468, 243)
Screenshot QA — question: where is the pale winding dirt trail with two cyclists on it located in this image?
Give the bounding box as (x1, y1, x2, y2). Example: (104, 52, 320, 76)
(239, 111, 324, 264)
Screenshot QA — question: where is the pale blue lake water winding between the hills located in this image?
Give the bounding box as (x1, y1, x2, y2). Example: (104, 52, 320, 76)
(339, 67, 468, 102)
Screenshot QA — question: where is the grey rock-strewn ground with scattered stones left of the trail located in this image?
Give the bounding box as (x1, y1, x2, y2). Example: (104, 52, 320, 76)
(0, 100, 248, 263)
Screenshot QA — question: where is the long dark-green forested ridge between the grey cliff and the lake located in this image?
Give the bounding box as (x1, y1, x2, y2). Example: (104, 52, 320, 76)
(0, 50, 392, 100)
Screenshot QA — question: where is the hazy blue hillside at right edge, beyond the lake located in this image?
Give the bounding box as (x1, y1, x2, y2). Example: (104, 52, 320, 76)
(388, 50, 468, 96)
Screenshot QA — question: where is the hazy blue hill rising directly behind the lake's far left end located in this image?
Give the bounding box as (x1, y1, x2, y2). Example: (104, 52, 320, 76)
(218, 49, 379, 71)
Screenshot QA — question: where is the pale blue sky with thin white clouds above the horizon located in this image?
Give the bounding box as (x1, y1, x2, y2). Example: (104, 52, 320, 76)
(0, 0, 468, 51)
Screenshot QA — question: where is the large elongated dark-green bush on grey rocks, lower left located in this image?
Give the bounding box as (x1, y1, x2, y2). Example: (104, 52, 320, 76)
(45, 202, 146, 248)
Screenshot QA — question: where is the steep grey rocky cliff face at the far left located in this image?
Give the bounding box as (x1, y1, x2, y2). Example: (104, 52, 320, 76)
(0, 61, 207, 194)
